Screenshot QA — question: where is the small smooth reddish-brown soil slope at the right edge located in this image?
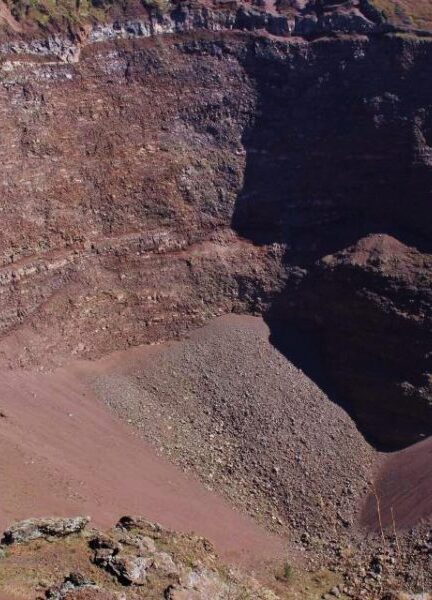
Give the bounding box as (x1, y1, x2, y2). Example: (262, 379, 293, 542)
(362, 438, 432, 530)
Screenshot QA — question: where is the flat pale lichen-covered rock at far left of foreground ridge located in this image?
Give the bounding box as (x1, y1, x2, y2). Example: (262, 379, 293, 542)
(2, 517, 90, 545)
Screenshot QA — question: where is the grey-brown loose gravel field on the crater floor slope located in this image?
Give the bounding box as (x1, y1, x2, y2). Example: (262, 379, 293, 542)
(94, 315, 378, 548)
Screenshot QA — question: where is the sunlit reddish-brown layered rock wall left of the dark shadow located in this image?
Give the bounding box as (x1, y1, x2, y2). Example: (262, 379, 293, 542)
(0, 38, 288, 364)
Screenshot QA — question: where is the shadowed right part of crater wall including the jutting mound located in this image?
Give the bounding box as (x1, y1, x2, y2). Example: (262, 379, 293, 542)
(233, 32, 431, 447)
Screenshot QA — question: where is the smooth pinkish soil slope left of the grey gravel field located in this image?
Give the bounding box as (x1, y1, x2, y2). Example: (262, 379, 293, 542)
(0, 370, 285, 567)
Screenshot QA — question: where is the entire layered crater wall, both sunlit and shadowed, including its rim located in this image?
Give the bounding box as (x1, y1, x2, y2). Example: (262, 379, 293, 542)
(0, 2, 432, 445)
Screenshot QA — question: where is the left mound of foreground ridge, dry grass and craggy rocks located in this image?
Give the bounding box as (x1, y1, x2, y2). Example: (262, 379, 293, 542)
(0, 517, 278, 600)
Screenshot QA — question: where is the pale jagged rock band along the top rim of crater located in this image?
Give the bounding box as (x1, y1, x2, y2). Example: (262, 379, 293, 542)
(0, 0, 432, 63)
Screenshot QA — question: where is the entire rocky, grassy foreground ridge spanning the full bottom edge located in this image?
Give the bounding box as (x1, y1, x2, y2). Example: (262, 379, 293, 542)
(0, 516, 430, 600)
